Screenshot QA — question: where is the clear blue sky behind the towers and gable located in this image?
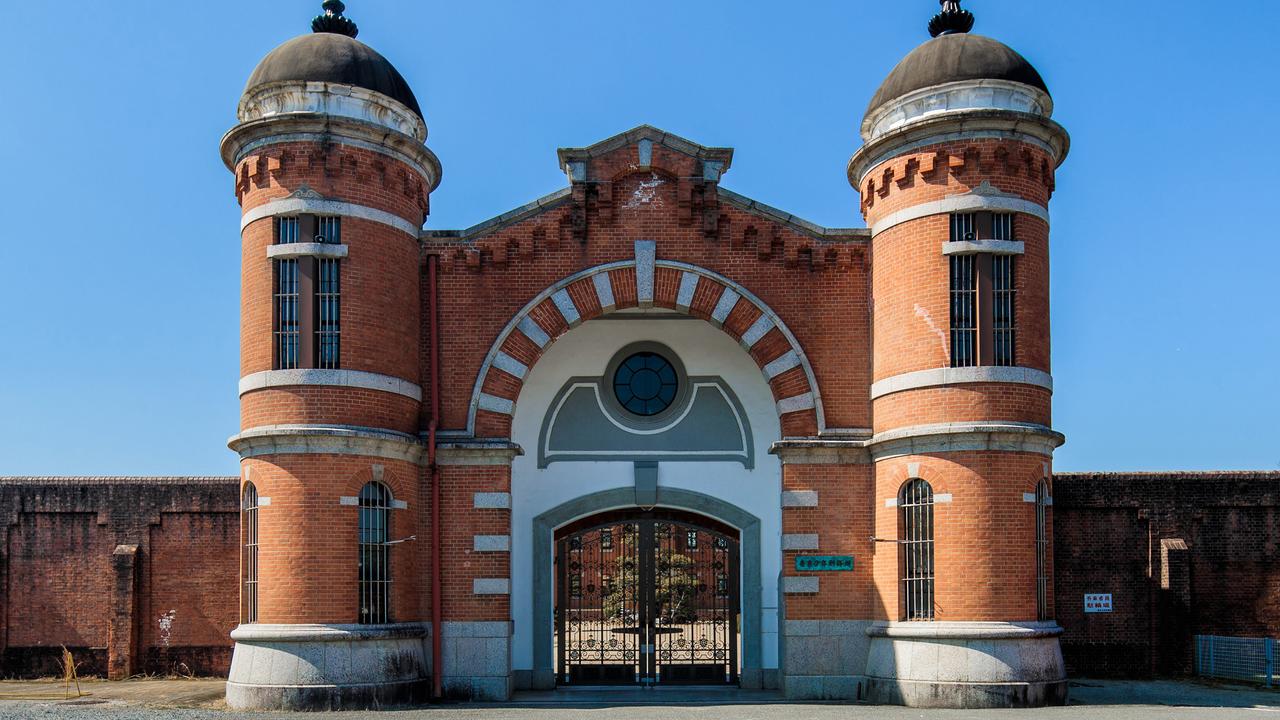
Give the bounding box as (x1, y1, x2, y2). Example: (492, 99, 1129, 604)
(0, 0, 1280, 474)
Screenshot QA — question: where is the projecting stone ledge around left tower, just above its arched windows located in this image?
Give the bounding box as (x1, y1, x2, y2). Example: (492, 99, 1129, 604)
(227, 424, 426, 462)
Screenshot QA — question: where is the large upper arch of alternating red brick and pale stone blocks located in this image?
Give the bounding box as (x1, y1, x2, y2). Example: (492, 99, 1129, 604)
(467, 258, 826, 437)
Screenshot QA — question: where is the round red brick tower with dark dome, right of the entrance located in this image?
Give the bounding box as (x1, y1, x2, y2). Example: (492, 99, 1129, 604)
(849, 0, 1069, 707)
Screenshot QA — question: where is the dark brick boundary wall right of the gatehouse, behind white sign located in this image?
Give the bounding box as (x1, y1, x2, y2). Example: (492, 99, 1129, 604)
(1053, 471, 1280, 678)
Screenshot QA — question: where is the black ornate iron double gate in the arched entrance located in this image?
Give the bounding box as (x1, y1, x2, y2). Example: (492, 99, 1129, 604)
(556, 511, 740, 685)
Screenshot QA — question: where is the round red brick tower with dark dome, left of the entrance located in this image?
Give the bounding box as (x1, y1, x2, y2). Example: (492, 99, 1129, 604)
(221, 0, 440, 710)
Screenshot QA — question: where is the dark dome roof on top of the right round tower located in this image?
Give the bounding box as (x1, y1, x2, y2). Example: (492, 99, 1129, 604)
(867, 33, 1048, 115)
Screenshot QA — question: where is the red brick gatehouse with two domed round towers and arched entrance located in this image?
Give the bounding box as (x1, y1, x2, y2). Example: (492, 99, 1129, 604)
(6, 0, 1274, 708)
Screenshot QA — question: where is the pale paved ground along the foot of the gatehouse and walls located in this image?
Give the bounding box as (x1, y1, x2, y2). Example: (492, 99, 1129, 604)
(0, 680, 1280, 720)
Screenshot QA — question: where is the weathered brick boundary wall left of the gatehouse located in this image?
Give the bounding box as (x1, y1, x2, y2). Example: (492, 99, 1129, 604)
(0, 477, 239, 679)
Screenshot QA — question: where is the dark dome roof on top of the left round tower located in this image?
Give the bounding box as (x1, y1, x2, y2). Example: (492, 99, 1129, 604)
(244, 32, 422, 118)
